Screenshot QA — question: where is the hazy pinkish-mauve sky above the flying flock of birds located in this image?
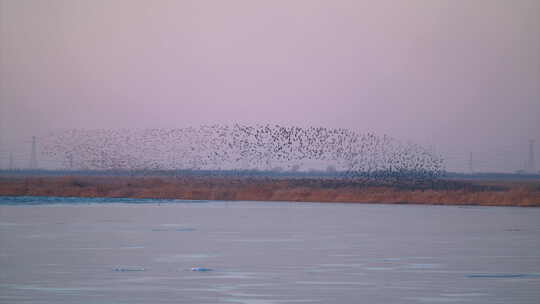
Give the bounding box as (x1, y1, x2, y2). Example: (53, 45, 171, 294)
(0, 0, 540, 170)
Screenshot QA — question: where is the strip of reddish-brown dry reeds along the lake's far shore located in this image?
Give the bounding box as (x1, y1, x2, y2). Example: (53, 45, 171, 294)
(0, 176, 540, 207)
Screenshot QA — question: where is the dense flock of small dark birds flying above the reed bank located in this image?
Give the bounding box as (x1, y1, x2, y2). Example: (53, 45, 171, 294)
(42, 124, 443, 180)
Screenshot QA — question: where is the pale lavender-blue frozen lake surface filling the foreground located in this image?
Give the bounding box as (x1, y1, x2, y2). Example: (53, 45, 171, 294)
(0, 197, 540, 304)
